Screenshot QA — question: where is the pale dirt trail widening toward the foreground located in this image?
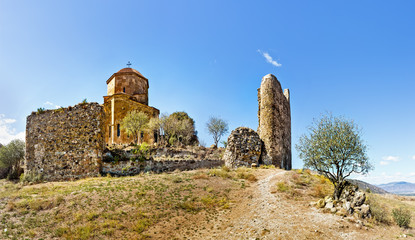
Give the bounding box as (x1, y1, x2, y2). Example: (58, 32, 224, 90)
(192, 170, 394, 239)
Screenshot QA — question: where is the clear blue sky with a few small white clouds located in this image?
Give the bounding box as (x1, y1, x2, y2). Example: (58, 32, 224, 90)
(0, 0, 415, 184)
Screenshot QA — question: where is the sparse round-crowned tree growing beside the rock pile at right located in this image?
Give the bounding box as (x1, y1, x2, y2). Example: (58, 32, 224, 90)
(296, 115, 372, 200)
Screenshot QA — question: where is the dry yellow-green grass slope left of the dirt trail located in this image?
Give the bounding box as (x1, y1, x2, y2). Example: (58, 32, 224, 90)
(0, 168, 247, 239)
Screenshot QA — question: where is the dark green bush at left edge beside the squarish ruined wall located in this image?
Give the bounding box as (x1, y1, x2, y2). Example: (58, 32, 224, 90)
(0, 139, 25, 179)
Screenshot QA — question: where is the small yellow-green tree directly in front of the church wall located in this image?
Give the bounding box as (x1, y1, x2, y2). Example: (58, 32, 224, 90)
(121, 111, 149, 144)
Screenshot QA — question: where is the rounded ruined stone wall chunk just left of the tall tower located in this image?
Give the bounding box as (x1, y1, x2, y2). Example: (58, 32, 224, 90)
(223, 127, 263, 168)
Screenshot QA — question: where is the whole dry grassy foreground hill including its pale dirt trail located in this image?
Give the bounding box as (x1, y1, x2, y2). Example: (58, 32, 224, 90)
(0, 168, 415, 239)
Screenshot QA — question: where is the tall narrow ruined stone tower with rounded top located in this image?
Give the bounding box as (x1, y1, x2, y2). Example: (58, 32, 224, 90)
(258, 74, 291, 170)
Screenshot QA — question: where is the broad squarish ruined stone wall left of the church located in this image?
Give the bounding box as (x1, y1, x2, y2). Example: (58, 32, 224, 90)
(25, 103, 105, 181)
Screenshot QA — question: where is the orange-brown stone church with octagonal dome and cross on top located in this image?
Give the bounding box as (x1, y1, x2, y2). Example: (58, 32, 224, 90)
(104, 66, 160, 145)
